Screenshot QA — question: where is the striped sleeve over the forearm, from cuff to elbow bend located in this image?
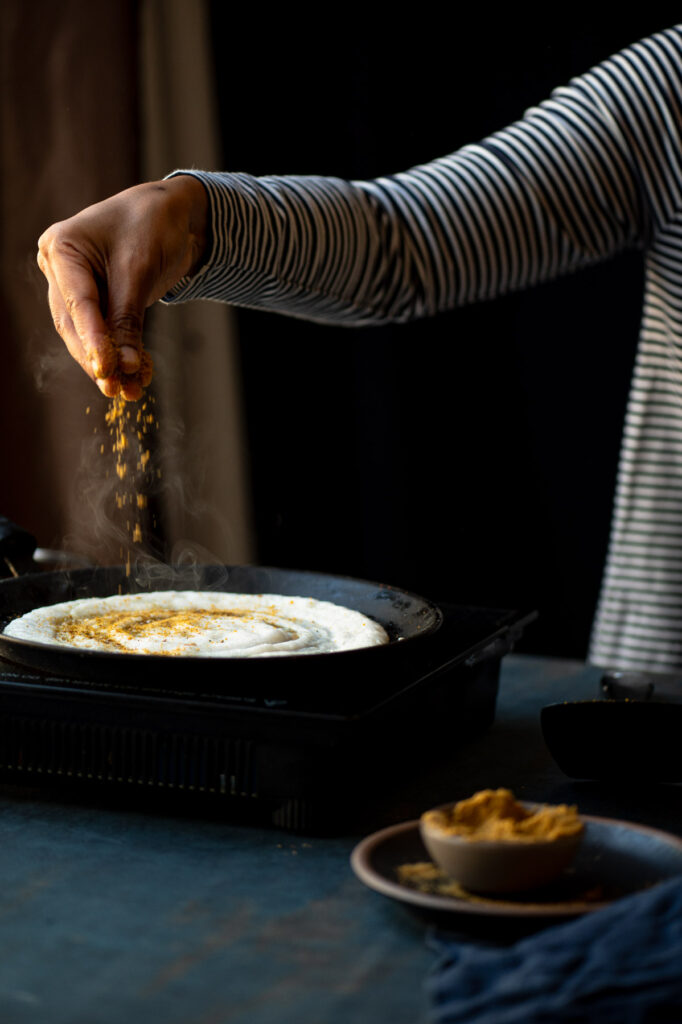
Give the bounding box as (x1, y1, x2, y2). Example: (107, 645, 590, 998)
(161, 171, 401, 324)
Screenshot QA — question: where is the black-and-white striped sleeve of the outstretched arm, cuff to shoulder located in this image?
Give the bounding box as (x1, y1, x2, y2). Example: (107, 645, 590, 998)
(166, 29, 681, 326)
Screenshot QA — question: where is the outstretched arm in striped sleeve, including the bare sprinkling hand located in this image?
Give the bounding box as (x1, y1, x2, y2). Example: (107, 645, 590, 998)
(39, 27, 682, 397)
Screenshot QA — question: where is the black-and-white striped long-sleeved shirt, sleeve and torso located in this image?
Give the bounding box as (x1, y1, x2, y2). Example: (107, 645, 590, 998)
(167, 26, 682, 673)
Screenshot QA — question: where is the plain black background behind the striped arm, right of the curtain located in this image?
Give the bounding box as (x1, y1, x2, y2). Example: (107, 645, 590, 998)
(212, 9, 675, 657)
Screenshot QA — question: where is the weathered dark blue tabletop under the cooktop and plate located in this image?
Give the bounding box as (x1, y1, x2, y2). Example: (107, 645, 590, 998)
(0, 654, 682, 1024)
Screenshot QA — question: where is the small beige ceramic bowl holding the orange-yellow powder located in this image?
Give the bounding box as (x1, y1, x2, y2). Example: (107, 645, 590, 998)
(419, 805, 583, 894)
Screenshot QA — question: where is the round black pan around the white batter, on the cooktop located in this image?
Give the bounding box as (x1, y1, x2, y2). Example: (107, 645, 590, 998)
(0, 565, 442, 698)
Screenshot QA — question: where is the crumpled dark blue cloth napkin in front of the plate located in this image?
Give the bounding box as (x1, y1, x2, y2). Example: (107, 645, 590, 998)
(427, 878, 682, 1024)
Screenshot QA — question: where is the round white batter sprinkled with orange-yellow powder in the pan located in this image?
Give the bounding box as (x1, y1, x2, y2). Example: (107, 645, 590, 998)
(4, 591, 388, 657)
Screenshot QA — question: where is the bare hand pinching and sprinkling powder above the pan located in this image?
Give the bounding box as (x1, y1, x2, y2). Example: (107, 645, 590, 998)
(38, 175, 208, 400)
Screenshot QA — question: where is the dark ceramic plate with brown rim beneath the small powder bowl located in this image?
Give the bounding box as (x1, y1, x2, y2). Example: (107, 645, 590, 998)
(350, 814, 682, 918)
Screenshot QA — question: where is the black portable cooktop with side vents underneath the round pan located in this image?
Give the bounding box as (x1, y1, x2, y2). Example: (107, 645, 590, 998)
(0, 603, 535, 831)
